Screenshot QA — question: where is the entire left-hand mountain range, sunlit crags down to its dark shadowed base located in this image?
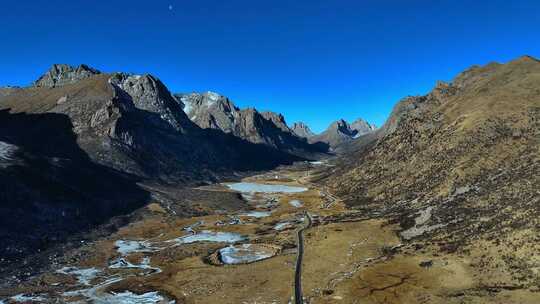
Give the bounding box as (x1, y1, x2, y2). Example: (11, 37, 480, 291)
(0, 64, 376, 257)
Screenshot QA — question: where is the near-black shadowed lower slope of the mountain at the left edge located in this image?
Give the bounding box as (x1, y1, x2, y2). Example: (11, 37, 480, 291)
(0, 110, 150, 262)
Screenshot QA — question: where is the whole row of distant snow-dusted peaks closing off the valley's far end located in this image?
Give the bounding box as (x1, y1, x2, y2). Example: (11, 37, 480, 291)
(175, 92, 376, 155)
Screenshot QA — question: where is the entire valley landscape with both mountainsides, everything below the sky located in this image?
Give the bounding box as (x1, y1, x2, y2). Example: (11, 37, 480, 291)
(0, 56, 540, 304)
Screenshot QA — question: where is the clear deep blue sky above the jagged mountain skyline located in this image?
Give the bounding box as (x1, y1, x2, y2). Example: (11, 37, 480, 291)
(0, 0, 540, 131)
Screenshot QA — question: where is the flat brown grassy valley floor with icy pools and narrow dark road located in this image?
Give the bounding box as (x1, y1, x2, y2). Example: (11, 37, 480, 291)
(0, 163, 539, 304)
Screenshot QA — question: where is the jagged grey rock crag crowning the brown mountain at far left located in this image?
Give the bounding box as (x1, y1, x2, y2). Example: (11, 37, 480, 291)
(34, 64, 101, 88)
